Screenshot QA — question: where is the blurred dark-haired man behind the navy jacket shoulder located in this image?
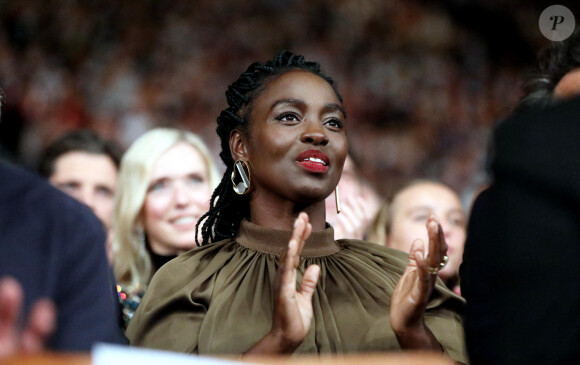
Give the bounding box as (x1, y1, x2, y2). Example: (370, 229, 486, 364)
(38, 130, 122, 263)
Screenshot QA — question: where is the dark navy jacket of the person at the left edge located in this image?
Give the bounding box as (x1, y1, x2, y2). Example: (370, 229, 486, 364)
(0, 162, 125, 351)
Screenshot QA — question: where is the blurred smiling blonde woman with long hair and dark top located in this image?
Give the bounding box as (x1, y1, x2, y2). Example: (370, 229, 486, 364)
(113, 128, 219, 324)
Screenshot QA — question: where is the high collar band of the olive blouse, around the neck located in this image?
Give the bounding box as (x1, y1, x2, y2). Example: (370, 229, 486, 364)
(236, 220, 340, 257)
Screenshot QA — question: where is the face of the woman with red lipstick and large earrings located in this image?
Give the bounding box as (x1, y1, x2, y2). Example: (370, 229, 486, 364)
(247, 71, 347, 204)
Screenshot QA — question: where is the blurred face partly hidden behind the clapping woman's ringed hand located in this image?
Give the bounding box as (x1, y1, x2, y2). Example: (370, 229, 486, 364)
(387, 182, 465, 280)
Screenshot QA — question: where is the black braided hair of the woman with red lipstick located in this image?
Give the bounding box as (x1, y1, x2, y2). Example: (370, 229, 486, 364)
(196, 51, 342, 245)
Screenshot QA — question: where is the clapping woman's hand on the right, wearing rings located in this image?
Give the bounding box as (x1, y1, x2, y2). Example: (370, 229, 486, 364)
(390, 216, 447, 351)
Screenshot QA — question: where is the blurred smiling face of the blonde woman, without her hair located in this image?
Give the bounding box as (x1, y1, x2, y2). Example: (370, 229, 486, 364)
(142, 142, 211, 255)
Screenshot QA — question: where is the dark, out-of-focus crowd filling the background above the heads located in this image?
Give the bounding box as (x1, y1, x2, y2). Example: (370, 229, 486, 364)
(0, 0, 580, 204)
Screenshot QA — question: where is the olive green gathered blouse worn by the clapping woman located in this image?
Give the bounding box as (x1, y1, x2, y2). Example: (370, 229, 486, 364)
(126, 221, 466, 362)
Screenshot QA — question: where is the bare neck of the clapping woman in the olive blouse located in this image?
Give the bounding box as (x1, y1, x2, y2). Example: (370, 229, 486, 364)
(250, 194, 326, 232)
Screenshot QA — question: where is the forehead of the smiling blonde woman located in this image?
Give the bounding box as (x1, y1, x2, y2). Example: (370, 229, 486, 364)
(151, 142, 205, 179)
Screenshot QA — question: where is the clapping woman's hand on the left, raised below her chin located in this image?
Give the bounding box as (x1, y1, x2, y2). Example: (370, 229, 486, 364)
(241, 213, 320, 354)
